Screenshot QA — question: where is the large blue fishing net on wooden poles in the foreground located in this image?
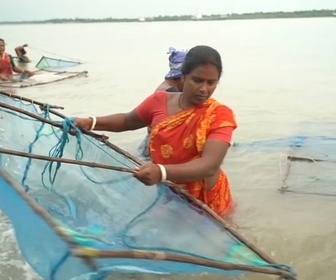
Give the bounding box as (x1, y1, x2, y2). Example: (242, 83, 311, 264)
(0, 92, 295, 280)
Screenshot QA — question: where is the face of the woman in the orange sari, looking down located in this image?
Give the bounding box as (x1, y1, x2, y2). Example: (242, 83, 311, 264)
(183, 64, 219, 106)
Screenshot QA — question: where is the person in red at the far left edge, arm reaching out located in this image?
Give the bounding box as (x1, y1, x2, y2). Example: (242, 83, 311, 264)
(0, 39, 33, 81)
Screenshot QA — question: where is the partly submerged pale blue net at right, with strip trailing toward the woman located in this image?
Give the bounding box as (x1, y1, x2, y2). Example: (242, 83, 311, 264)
(235, 122, 336, 196)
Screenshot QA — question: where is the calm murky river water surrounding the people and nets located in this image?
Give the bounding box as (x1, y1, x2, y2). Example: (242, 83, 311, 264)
(0, 18, 336, 280)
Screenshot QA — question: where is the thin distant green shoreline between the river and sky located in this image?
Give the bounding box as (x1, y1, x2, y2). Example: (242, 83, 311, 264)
(0, 10, 336, 24)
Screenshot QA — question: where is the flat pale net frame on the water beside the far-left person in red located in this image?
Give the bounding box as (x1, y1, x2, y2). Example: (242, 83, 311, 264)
(0, 70, 88, 88)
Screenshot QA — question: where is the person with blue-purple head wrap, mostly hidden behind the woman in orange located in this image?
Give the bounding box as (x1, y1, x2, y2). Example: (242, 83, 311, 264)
(138, 47, 188, 160)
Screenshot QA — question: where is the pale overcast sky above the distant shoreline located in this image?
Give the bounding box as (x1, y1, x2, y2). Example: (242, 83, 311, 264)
(0, 0, 336, 21)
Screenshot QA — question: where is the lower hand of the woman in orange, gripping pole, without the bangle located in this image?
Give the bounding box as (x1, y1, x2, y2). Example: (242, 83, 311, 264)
(134, 162, 161, 186)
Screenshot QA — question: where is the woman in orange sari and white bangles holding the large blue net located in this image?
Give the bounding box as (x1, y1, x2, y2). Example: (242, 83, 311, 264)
(73, 45, 237, 216)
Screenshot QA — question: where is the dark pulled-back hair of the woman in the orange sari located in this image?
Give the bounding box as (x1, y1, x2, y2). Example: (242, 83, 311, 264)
(181, 45, 223, 78)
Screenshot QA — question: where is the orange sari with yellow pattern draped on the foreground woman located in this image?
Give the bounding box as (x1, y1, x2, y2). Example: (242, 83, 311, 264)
(149, 98, 237, 216)
